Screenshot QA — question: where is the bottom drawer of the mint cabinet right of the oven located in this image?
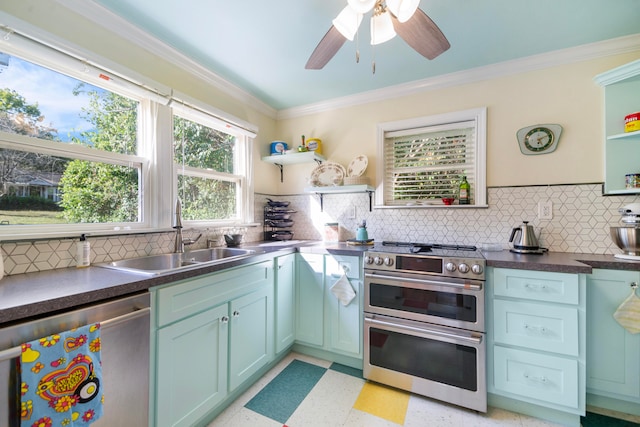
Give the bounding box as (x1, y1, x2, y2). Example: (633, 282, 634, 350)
(493, 346, 579, 408)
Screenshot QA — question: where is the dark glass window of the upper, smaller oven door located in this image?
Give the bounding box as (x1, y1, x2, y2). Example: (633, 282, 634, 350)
(369, 283, 477, 323)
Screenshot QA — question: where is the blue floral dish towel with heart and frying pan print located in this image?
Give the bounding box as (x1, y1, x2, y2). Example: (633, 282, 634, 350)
(19, 323, 102, 427)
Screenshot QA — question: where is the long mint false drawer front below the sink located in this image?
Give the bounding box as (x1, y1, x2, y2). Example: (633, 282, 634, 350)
(157, 261, 273, 327)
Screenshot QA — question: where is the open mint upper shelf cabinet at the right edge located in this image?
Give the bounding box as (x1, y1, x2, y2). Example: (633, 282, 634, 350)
(595, 60, 640, 195)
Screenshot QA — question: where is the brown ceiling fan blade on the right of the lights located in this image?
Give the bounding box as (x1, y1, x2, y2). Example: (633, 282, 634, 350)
(391, 8, 451, 59)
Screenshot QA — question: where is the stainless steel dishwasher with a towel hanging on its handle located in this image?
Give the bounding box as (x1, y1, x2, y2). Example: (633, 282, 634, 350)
(0, 293, 150, 427)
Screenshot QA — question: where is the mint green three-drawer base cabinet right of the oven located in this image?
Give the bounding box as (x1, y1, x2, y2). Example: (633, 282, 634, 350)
(486, 268, 586, 425)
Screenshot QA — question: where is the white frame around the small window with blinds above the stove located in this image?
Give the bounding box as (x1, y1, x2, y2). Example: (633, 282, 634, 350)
(374, 107, 488, 209)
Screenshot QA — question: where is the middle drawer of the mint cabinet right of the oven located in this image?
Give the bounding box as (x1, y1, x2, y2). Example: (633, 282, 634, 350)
(493, 299, 580, 356)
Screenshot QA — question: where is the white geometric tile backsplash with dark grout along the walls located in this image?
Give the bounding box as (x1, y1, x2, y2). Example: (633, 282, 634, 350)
(1, 184, 640, 275)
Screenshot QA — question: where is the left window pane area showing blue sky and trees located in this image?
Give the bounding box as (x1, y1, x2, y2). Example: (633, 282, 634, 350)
(0, 53, 144, 234)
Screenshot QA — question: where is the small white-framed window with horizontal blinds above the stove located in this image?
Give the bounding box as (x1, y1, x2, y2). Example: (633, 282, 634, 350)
(376, 108, 486, 207)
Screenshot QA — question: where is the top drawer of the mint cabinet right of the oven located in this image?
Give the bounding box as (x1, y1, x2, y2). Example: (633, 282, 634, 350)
(493, 268, 580, 304)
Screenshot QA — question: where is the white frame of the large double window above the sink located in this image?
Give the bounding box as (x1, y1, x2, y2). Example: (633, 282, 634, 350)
(0, 28, 258, 240)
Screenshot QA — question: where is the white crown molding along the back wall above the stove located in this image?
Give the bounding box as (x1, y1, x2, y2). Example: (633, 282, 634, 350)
(277, 34, 640, 120)
